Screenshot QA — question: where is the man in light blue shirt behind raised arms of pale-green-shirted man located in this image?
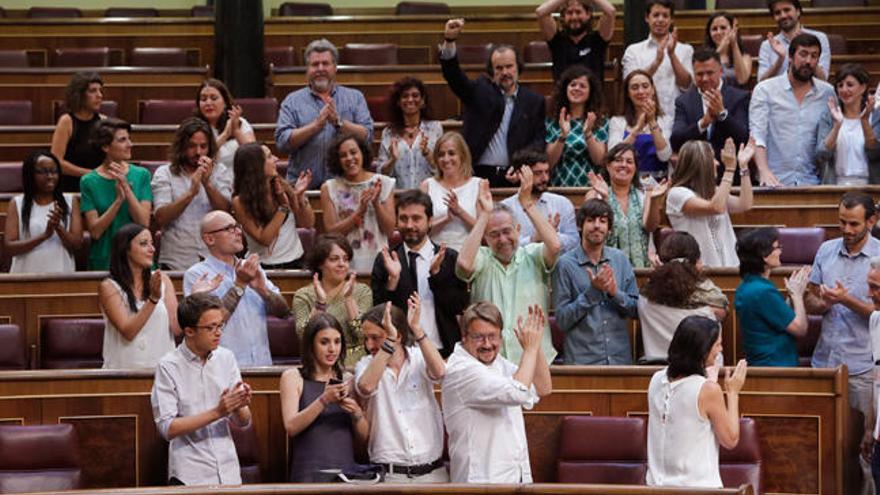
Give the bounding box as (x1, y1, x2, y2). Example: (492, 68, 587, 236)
(501, 150, 580, 253)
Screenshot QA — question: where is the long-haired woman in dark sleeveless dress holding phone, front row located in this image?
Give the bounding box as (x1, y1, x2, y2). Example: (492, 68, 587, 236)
(279, 313, 370, 483)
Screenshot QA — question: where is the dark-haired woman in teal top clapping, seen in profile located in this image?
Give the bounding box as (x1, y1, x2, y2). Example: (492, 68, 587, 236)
(733, 231, 810, 366)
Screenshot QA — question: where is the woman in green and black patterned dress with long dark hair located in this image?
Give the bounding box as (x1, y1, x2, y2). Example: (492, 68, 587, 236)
(545, 64, 608, 187)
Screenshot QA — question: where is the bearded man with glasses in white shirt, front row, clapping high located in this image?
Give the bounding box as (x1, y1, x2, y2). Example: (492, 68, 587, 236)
(442, 301, 553, 483)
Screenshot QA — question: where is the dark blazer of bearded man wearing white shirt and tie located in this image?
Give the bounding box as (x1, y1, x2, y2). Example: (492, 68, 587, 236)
(370, 241, 470, 358)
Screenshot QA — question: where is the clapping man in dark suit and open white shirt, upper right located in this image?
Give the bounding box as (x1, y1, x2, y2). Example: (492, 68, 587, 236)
(670, 48, 749, 179)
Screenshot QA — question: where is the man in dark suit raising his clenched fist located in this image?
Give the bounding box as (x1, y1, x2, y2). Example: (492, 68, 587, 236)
(440, 19, 545, 187)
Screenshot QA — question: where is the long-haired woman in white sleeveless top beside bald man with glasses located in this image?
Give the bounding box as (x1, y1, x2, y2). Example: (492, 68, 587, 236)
(98, 223, 180, 369)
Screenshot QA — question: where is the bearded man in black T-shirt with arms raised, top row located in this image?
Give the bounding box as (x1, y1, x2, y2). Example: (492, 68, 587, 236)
(535, 0, 616, 81)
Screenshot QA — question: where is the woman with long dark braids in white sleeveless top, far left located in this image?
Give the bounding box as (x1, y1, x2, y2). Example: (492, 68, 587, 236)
(3, 150, 82, 273)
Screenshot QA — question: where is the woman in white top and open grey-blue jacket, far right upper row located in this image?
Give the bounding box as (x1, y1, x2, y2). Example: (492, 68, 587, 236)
(816, 64, 880, 186)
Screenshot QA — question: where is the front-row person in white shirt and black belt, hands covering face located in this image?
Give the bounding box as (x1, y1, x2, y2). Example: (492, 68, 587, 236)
(355, 300, 449, 483)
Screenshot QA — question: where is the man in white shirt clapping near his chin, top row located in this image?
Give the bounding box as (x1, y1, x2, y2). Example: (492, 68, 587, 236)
(623, 0, 694, 123)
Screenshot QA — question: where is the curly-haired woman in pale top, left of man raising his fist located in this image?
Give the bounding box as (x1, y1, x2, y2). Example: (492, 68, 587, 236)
(377, 76, 443, 189)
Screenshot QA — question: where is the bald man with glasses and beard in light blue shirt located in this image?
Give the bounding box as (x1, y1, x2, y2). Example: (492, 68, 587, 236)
(183, 211, 290, 367)
